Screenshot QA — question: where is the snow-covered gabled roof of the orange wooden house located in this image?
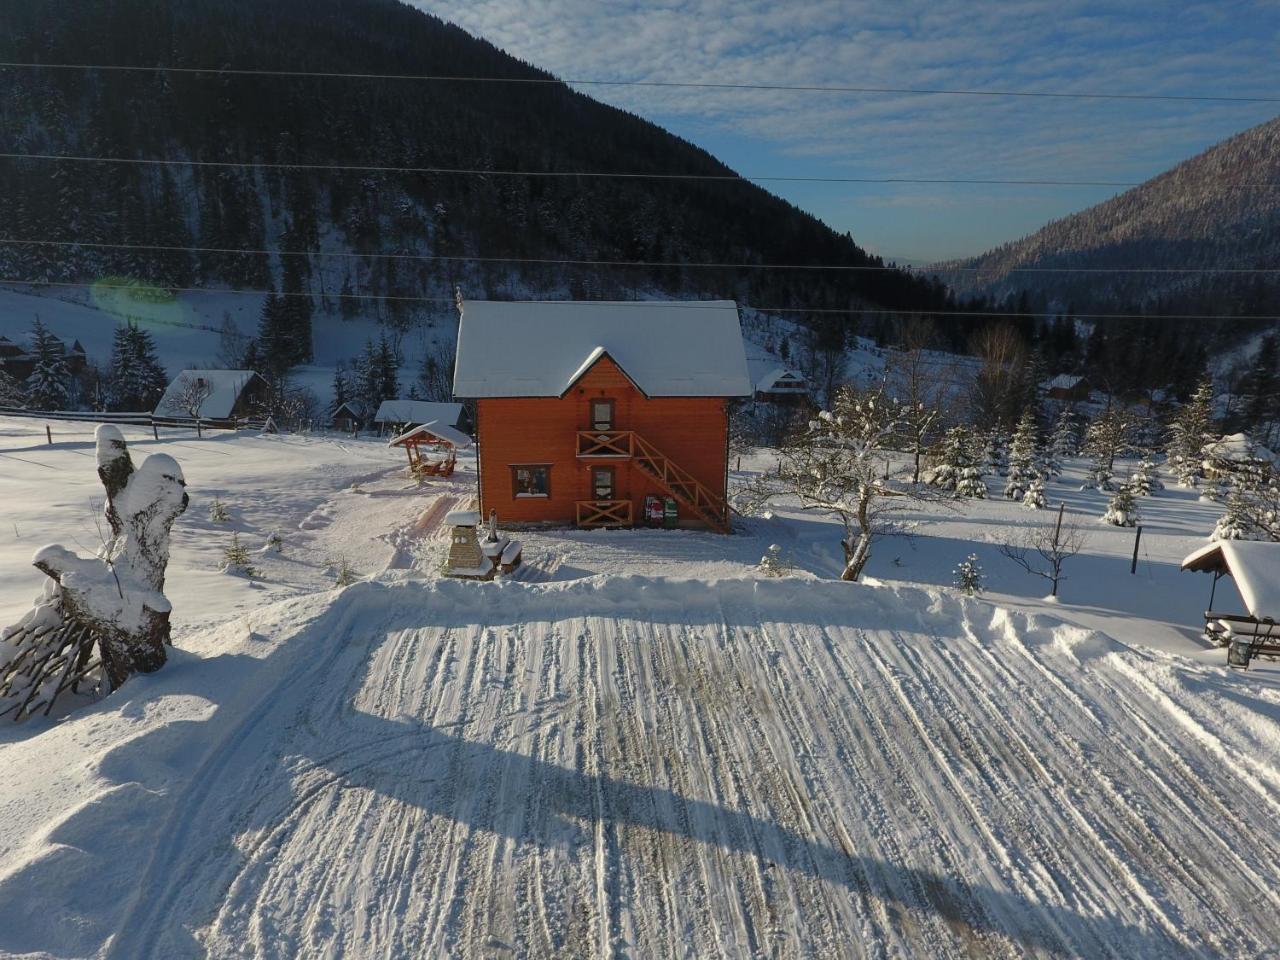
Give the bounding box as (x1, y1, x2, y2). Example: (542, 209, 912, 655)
(453, 300, 751, 397)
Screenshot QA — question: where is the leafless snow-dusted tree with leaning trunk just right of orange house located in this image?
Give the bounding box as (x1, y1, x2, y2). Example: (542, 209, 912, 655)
(740, 387, 931, 580)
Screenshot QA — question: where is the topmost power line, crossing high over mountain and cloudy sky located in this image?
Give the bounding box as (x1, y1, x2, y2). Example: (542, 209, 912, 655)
(0, 61, 1280, 104)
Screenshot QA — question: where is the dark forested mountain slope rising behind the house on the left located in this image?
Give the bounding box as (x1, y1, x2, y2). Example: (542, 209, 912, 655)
(0, 0, 946, 321)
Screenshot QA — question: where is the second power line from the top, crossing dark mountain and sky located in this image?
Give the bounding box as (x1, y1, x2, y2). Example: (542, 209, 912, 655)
(10, 152, 1280, 189)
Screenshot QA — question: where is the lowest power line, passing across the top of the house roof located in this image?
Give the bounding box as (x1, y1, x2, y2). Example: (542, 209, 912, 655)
(0, 276, 1280, 320)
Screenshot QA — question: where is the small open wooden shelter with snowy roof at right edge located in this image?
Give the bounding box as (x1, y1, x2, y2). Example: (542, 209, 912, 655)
(1181, 540, 1280, 668)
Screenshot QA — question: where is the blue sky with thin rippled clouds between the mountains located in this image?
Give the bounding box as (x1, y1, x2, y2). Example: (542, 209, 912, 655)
(413, 0, 1280, 262)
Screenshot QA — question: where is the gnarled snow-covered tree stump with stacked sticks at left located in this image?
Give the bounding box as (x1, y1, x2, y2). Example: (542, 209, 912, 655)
(0, 425, 188, 719)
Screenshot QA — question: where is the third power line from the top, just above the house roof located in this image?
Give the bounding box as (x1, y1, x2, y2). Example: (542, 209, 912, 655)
(0, 237, 1280, 275)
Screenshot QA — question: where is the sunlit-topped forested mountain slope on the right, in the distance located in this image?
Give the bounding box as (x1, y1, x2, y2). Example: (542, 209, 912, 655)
(940, 118, 1280, 315)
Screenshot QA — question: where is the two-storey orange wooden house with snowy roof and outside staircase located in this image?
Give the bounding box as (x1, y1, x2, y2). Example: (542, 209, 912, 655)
(453, 301, 751, 531)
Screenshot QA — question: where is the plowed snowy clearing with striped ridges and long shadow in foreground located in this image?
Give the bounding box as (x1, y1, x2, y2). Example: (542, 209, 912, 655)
(0, 577, 1280, 957)
